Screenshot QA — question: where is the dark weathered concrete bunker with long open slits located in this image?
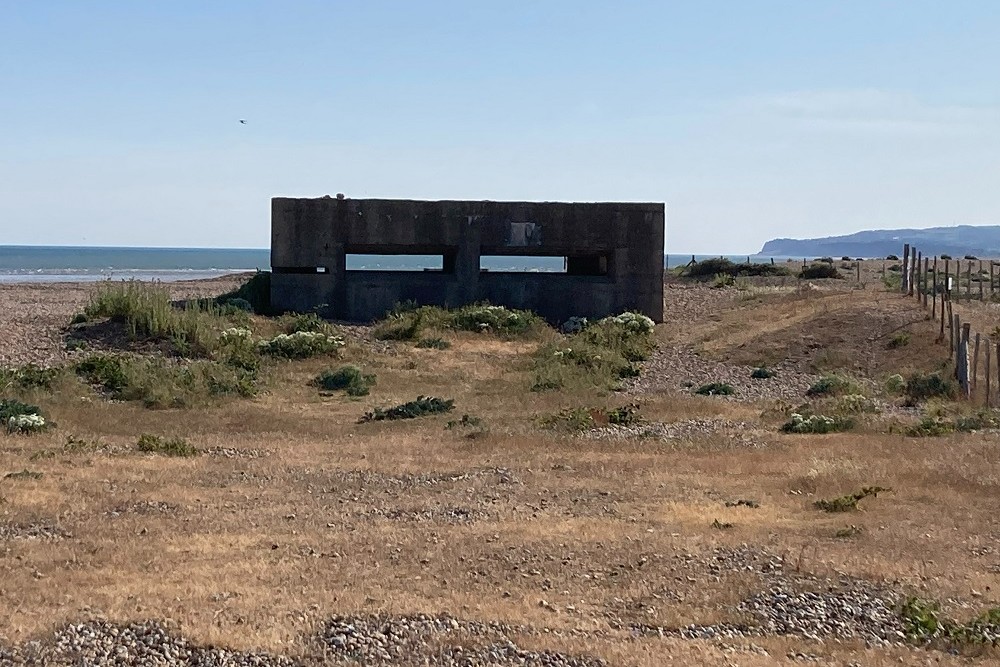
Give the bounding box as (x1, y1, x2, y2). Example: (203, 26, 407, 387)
(271, 197, 664, 322)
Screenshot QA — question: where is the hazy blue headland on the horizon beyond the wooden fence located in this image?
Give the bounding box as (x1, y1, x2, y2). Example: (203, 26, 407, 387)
(759, 225, 1000, 257)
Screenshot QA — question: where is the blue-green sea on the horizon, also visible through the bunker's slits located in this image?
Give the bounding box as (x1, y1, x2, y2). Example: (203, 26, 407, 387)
(0, 246, 787, 283)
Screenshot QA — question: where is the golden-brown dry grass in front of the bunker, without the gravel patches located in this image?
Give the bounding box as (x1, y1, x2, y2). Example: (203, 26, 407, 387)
(0, 280, 1000, 666)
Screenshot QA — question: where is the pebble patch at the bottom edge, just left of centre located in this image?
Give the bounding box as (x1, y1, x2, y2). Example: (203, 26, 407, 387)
(322, 615, 607, 667)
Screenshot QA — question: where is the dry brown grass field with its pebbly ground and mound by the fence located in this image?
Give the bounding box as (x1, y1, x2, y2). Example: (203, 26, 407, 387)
(0, 265, 1000, 667)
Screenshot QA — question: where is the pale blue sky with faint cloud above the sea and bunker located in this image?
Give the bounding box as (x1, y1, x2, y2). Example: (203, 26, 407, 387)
(0, 0, 1000, 253)
